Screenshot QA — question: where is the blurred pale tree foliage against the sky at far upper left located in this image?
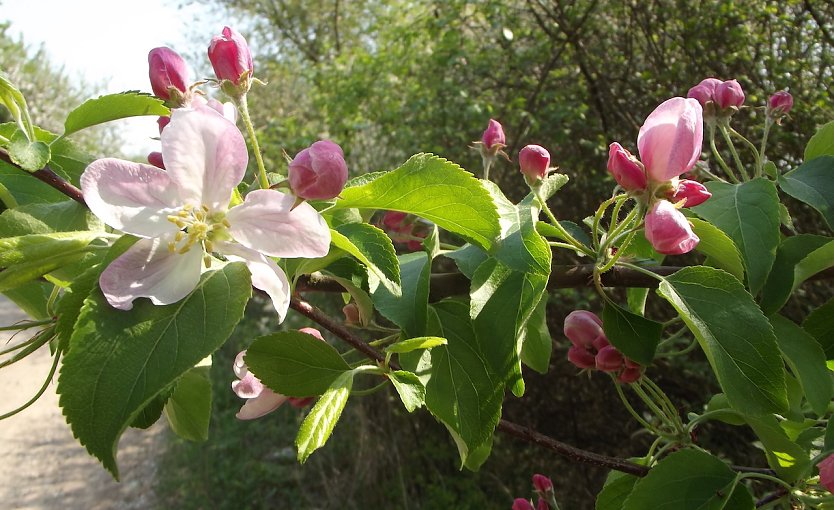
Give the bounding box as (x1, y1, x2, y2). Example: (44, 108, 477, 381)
(0, 23, 122, 156)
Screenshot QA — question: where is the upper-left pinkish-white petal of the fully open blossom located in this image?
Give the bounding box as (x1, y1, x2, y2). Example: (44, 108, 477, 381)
(81, 158, 180, 237)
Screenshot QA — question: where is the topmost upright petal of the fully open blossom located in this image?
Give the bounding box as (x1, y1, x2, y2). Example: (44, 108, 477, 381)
(161, 108, 249, 211)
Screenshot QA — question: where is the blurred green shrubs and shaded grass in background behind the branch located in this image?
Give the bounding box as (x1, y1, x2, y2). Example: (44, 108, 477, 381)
(162, 0, 834, 509)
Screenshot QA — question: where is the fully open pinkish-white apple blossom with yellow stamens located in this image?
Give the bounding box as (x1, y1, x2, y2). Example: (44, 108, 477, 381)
(81, 107, 330, 320)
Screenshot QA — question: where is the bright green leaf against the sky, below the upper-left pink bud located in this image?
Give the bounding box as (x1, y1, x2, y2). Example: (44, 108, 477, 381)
(63, 91, 171, 136)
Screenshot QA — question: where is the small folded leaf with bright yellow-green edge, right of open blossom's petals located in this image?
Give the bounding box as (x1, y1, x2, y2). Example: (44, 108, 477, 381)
(330, 223, 402, 296)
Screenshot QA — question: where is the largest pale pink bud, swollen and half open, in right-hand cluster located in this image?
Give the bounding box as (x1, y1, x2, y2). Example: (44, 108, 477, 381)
(637, 97, 704, 182)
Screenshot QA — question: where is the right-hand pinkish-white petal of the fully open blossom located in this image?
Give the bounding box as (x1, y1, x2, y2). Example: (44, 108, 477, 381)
(226, 189, 330, 258)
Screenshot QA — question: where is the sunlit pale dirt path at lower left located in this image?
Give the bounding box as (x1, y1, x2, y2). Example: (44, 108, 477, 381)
(0, 295, 165, 510)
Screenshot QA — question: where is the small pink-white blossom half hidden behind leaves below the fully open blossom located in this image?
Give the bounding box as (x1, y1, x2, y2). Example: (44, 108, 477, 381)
(232, 328, 324, 420)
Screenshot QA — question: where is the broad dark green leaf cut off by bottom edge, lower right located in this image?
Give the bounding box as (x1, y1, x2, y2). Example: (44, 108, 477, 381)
(623, 450, 752, 510)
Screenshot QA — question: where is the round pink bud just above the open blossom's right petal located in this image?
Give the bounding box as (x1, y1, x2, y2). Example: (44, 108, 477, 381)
(289, 140, 348, 200)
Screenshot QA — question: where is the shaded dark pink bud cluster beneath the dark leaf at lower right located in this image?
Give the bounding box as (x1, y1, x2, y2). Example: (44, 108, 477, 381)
(564, 310, 643, 384)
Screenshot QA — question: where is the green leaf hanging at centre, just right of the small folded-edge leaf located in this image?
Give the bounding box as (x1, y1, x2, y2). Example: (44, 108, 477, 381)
(371, 251, 431, 338)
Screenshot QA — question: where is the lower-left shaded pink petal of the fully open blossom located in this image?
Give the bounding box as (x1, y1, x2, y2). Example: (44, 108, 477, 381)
(99, 236, 203, 310)
